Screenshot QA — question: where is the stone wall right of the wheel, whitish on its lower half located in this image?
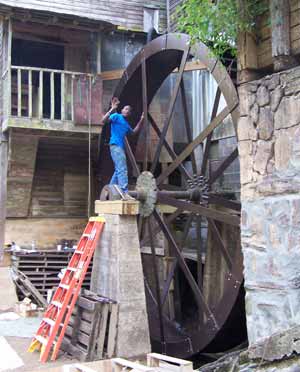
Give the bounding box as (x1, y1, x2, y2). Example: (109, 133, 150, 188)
(238, 67, 300, 345)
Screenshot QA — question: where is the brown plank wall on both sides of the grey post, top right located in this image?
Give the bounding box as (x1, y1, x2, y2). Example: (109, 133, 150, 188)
(257, 0, 300, 68)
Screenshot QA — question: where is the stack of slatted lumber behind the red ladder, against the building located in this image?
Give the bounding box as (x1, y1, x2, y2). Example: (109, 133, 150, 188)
(12, 250, 92, 300)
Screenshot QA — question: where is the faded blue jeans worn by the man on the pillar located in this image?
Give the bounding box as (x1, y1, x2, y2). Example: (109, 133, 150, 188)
(109, 145, 128, 193)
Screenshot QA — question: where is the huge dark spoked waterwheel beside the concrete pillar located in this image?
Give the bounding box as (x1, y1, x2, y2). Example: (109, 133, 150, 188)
(99, 34, 243, 357)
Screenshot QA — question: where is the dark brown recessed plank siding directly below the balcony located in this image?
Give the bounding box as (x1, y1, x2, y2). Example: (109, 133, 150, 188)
(30, 138, 92, 217)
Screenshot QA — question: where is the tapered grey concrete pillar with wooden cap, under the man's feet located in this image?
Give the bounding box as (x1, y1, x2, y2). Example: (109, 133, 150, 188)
(91, 201, 151, 358)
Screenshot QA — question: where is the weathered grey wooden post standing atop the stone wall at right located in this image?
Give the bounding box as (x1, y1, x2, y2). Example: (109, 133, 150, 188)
(270, 0, 297, 71)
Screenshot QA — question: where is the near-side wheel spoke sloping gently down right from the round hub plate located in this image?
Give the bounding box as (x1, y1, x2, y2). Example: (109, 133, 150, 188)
(158, 193, 240, 226)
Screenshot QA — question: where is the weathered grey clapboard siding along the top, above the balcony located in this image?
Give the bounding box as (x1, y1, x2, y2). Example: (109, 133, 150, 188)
(0, 0, 166, 31)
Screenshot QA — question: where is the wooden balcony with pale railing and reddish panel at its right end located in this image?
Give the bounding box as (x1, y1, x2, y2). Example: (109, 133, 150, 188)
(2, 66, 102, 133)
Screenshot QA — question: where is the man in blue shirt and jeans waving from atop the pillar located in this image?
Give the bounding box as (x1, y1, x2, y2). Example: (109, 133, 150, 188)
(102, 97, 144, 199)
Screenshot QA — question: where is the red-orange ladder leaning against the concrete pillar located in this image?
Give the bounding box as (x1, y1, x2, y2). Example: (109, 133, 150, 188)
(28, 217, 105, 363)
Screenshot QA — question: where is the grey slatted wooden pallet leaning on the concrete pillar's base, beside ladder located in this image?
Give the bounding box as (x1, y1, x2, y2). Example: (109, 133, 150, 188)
(62, 290, 118, 362)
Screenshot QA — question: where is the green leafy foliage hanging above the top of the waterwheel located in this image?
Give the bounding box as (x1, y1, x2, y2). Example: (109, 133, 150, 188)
(176, 0, 267, 57)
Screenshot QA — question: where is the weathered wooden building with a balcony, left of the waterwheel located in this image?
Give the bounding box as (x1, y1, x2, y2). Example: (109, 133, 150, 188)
(0, 0, 166, 253)
